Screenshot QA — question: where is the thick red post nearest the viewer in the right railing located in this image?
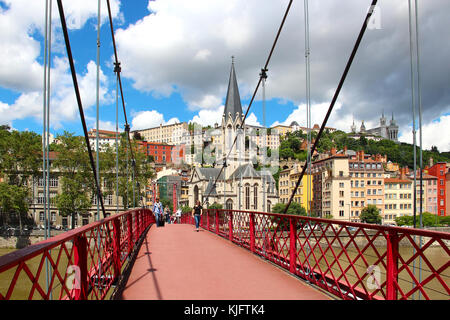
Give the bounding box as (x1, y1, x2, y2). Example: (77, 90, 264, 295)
(386, 231, 399, 300)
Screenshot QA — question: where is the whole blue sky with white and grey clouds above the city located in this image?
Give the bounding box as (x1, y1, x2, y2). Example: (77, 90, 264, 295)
(0, 0, 450, 150)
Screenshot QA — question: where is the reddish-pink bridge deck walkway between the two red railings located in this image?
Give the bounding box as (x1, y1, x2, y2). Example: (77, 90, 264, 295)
(118, 224, 330, 300)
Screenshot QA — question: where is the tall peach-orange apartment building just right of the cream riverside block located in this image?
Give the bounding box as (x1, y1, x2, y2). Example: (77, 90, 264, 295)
(349, 151, 386, 221)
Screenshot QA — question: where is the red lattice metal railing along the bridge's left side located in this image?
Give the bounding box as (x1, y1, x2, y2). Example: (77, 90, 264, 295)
(0, 209, 155, 300)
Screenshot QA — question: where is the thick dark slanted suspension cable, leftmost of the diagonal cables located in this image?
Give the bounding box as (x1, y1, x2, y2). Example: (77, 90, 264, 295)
(58, 0, 106, 218)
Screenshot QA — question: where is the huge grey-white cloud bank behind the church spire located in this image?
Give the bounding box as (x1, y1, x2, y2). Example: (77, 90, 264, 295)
(117, 0, 450, 148)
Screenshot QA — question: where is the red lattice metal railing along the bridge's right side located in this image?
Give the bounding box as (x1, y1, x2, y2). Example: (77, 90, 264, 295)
(182, 210, 450, 300)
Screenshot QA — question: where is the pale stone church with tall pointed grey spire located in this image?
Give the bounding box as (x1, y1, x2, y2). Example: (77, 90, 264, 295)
(189, 61, 278, 212)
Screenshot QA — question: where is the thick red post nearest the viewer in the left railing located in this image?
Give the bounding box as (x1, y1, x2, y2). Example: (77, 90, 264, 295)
(73, 235, 88, 300)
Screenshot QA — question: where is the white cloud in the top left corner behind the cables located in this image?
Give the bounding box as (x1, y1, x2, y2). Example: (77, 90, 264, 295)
(0, 0, 120, 92)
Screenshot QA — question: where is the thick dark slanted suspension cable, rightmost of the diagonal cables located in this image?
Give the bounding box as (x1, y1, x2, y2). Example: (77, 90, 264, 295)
(284, 0, 378, 214)
